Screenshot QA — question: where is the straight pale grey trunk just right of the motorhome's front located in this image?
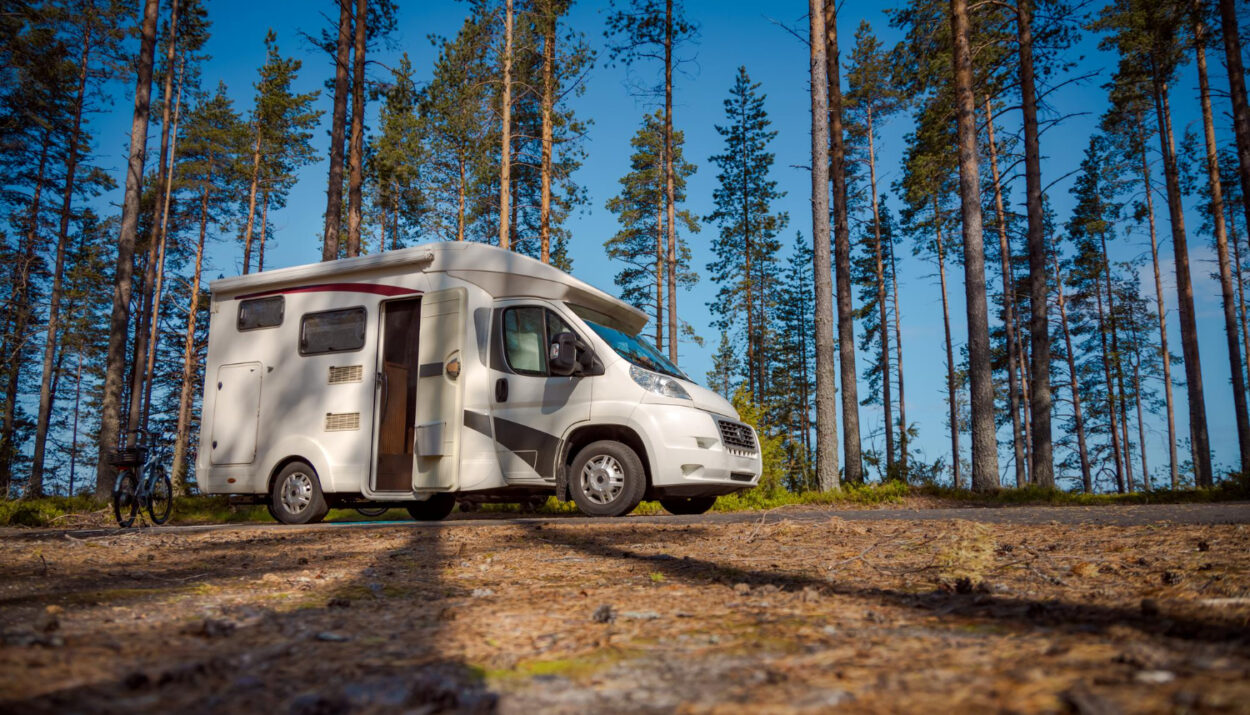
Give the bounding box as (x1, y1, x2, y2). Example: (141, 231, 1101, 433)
(808, 0, 841, 491)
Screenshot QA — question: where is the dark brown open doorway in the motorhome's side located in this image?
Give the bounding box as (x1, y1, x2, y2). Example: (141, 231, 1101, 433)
(374, 298, 421, 491)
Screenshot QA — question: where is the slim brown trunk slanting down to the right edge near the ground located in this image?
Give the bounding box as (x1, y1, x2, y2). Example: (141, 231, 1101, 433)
(1194, 11, 1250, 473)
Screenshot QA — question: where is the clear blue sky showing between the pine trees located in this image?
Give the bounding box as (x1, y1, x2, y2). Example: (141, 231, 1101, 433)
(85, 0, 1236, 479)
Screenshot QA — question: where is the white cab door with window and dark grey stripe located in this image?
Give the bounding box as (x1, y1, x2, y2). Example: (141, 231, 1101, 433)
(491, 304, 591, 484)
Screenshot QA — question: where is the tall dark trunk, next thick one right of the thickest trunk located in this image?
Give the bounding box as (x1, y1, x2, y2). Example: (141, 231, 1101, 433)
(1016, 0, 1055, 488)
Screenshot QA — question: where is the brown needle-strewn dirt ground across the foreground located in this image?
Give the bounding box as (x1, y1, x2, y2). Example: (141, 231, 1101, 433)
(0, 508, 1250, 714)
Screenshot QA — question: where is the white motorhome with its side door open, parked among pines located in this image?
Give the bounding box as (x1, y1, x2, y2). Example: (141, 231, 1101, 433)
(195, 243, 761, 524)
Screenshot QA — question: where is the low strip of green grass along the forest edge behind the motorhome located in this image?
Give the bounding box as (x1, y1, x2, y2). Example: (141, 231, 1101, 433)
(0, 479, 1250, 528)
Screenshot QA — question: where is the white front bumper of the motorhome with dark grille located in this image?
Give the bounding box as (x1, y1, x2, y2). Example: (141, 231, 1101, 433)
(634, 404, 764, 496)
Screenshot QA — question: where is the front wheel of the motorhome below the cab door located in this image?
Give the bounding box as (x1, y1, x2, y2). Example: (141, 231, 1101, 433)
(569, 440, 646, 516)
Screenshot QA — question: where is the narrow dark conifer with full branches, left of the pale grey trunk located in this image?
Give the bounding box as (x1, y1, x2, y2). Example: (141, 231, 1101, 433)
(704, 68, 789, 405)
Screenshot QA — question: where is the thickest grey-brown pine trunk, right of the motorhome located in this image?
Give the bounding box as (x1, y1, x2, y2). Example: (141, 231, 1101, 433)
(950, 0, 1000, 491)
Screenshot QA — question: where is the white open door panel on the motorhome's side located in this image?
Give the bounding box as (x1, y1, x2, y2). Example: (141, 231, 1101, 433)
(413, 288, 469, 490)
